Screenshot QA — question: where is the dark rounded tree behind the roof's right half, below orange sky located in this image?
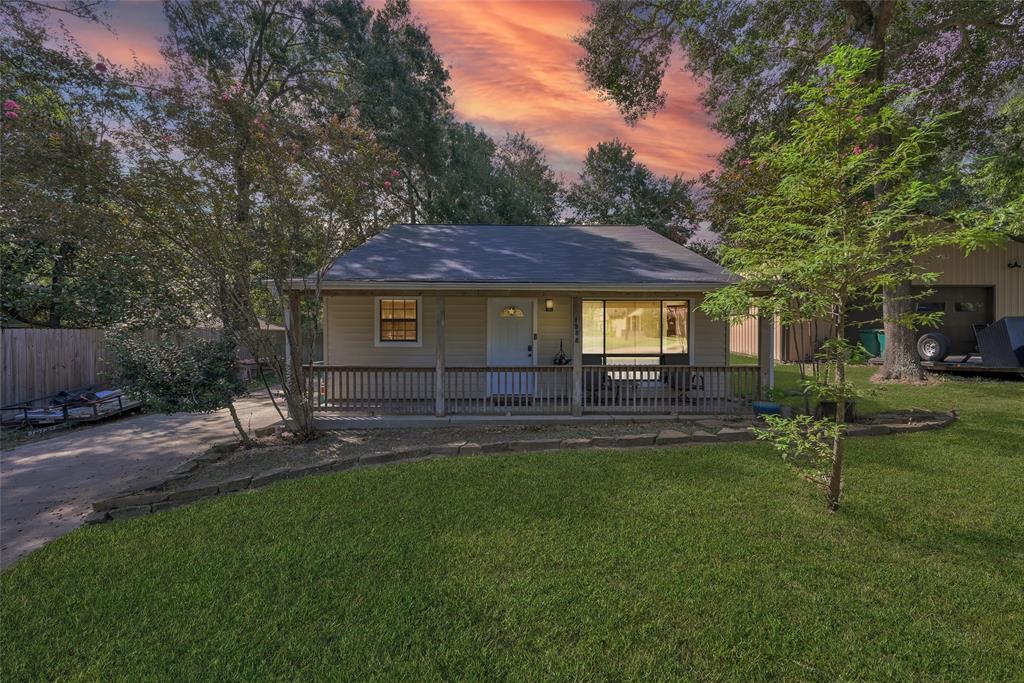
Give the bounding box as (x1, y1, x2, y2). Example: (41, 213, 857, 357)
(565, 139, 696, 239)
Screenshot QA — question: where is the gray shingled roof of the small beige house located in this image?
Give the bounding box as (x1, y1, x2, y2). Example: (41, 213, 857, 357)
(315, 224, 734, 286)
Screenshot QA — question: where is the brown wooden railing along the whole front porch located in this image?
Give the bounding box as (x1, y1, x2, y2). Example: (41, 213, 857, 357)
(309, 366, 761, 415)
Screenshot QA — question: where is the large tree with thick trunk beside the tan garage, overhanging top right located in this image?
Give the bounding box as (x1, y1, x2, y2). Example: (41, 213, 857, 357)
(579, 0, 1024, 379)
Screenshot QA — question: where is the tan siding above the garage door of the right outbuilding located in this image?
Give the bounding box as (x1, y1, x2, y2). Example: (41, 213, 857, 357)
(923, 242, 1024, 321)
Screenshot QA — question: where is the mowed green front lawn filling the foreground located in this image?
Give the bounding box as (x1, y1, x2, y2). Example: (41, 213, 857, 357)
(6, 368, 1024, 681)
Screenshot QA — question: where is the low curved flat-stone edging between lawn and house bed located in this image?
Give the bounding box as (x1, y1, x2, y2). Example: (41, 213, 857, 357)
(85, 412, 956, 524)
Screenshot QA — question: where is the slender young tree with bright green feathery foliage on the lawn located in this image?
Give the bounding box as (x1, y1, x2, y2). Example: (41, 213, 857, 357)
(702, 46, 959, 510)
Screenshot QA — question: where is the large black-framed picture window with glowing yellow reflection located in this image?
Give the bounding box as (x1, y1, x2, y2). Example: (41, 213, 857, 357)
(583, 300, 689, 365)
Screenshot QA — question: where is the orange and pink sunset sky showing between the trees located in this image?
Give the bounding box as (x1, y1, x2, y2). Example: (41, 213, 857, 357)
(61, 0, 725, 178)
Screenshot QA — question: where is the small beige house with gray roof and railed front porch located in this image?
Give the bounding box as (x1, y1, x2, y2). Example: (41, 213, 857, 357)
(290, 224, 771, 417)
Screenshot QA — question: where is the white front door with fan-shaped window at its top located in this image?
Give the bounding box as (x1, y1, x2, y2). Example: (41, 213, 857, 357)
(487, 298, 537, 396)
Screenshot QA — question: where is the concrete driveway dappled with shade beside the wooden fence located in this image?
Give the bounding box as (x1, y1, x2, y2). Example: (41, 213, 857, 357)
(0, 395, 282, 567)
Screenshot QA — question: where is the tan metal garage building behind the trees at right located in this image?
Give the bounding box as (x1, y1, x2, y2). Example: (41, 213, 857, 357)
(729, 242, 1024, 362)
